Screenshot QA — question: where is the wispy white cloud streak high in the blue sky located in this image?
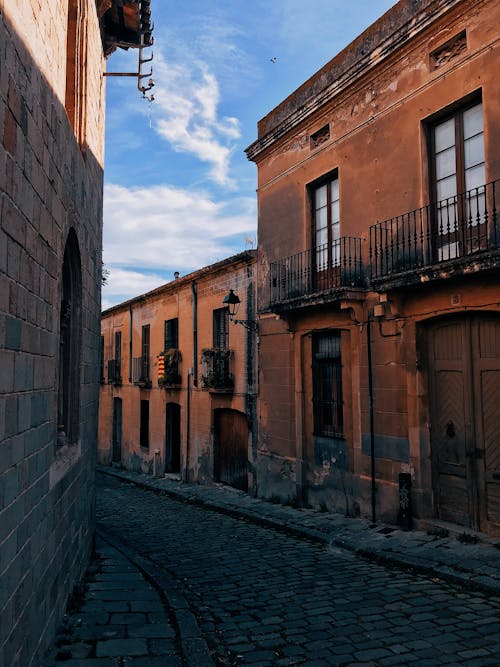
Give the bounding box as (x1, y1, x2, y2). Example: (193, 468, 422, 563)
(154, 54, 240, 187)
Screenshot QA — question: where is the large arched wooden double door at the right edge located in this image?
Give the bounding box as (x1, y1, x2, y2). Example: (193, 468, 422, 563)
(429, 315, 500, 532)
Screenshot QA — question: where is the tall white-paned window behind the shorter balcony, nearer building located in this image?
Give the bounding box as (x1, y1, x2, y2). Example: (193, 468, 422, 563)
(312, 176, 340, 288)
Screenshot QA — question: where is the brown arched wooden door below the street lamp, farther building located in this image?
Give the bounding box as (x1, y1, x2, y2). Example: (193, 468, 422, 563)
(214, 409, 248, 491)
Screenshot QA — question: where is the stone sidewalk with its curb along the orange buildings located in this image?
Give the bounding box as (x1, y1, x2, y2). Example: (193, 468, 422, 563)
(97, 466, 500, 595)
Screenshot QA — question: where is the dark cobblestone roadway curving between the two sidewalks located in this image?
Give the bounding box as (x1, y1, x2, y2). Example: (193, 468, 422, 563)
(97, 475, 500, 667)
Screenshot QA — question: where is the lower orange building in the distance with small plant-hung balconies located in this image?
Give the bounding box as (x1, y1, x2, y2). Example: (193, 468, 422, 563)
(98, 251, 256, 490)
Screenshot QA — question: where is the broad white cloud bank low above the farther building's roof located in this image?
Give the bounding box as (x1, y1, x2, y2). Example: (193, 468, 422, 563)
(104, 185, 257, 286)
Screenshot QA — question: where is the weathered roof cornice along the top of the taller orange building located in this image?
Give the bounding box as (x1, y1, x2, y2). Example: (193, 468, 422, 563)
(245, 0, 463, 161)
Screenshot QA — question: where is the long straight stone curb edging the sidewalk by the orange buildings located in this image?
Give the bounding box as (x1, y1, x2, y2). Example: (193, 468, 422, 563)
(97, 467, 500, 596)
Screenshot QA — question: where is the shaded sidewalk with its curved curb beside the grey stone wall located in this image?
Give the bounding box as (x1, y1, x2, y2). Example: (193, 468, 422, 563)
(46, 535, 213, 667)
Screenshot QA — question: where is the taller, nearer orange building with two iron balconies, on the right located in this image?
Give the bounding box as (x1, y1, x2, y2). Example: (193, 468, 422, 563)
(247, 0, 500, 534)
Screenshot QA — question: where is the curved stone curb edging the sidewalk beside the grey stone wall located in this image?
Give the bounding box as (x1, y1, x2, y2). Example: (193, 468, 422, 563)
(96, 528, 215, 667)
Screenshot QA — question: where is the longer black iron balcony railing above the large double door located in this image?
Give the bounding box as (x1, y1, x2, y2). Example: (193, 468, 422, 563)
(370, 180, 500, 279)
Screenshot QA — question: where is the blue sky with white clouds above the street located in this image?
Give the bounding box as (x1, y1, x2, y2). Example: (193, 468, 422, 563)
(102, 0, 395, 309)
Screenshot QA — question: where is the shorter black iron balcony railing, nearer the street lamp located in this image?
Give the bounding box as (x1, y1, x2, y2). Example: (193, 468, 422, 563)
(269, 236, 363, 306)
